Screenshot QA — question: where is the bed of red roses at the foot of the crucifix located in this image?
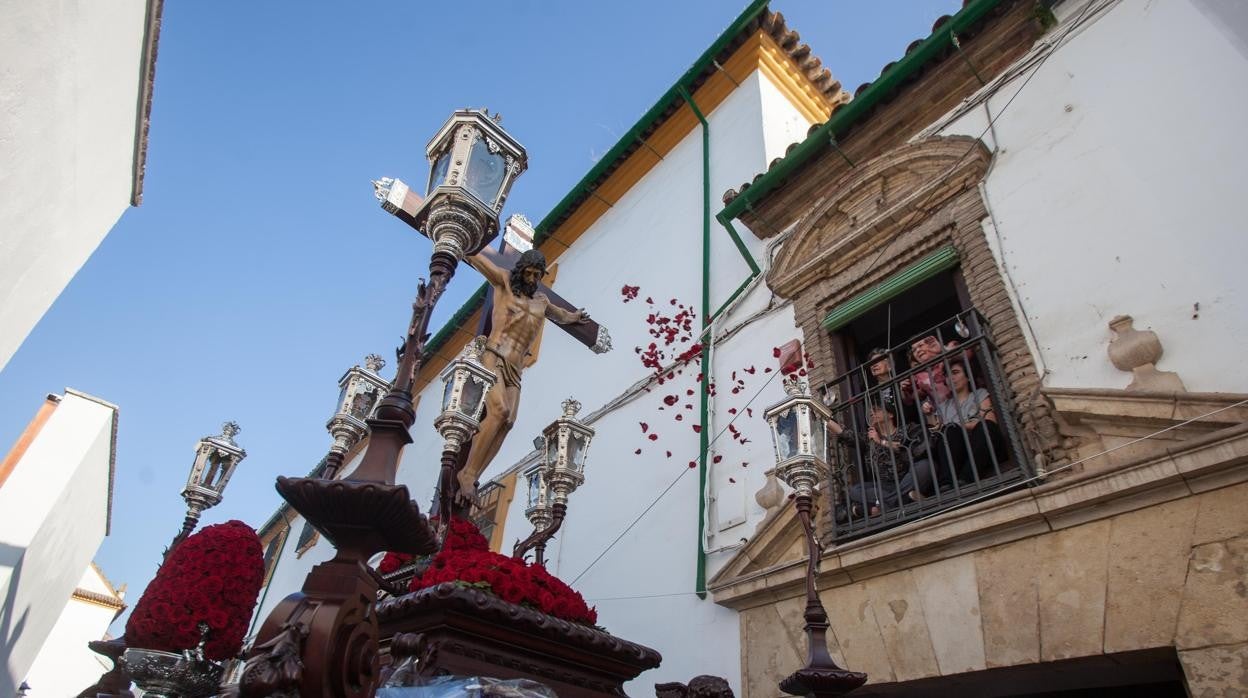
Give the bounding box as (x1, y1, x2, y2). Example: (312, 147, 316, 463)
(383, 518, 598, 626)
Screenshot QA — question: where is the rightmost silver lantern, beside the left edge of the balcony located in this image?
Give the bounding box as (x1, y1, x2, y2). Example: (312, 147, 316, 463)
(764, 376, 831, 496)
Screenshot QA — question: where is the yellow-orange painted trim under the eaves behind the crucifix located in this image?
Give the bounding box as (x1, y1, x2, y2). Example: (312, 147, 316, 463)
(416, 29, 844, 382)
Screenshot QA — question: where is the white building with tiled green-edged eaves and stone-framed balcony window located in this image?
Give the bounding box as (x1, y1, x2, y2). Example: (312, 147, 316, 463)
(250, 0, 1248, 698)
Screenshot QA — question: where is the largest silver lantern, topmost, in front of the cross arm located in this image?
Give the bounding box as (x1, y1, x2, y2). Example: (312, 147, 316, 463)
(409, 109, 529, 260)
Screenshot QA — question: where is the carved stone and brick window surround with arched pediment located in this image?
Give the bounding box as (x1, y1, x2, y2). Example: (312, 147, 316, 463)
(768, 136, 1066, 541)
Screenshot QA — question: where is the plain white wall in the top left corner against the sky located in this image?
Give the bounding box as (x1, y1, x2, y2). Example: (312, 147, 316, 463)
(0, 0, 146, 368)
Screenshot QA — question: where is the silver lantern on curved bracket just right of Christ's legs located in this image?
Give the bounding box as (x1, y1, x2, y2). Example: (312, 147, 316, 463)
(512, 397, 594, 564)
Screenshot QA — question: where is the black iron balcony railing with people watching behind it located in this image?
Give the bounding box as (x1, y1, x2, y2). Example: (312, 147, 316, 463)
(824, 310, 1032, 541)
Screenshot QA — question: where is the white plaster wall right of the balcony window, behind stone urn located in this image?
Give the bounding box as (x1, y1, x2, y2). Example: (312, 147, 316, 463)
(943, 0, 1248, 392)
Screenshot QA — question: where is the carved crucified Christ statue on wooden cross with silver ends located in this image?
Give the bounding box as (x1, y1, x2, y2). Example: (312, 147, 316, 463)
(373, 179, 612, 511)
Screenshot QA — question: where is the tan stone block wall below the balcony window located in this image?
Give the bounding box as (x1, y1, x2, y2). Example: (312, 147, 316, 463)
(740, 483, 1248, 698)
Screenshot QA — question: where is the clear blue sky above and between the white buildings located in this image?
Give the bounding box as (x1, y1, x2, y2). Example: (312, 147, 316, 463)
(0, 0, 960, 632)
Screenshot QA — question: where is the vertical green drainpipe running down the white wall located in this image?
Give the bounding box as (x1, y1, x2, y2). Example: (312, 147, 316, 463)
(680, 85, 714, 599)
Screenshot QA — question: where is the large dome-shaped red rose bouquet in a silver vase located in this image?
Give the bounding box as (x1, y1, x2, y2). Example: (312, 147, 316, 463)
(126, 521, 265, 661)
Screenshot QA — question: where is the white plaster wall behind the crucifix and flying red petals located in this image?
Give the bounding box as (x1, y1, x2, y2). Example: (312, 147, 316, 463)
(254, 66, 806, 694)
